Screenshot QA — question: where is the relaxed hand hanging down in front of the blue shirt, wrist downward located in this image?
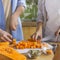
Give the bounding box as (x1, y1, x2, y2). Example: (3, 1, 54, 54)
(10, 14, 18, 30)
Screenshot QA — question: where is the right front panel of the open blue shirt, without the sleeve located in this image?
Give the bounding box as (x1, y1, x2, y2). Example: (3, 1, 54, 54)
(11, 0, 23, 41)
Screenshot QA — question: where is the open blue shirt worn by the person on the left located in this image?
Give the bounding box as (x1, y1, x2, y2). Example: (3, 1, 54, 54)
(0, 0, 26, 41)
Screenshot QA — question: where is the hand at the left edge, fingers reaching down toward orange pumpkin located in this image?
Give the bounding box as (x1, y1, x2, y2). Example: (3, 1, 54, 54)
(0, 29, 12, 42)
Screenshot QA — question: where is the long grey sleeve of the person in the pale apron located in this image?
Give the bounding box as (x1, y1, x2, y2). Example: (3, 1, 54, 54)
(37, 0, 44, 22)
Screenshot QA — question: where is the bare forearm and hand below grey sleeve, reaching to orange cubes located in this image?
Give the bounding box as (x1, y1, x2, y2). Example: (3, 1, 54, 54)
(31, 23, 42, 40)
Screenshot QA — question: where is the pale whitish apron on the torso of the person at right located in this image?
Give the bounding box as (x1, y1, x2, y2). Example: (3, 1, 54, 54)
(45, 0, 60, 36)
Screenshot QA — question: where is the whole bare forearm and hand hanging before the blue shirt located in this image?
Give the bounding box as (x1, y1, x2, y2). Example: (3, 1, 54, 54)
(10, 6, 24, 30)
